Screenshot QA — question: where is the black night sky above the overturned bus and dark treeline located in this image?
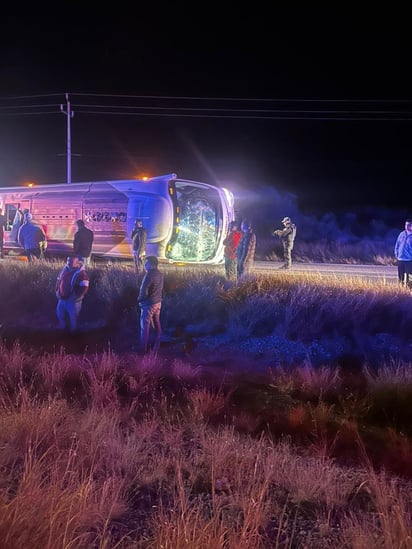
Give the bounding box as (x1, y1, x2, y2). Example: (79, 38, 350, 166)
(0, 8, 412, 212)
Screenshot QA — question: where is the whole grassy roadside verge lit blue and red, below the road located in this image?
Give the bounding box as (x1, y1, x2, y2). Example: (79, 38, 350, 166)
(0, 252, 412, 549)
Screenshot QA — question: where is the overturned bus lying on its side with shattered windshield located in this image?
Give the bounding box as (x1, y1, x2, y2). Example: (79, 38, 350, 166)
(0, 174, 235, 263)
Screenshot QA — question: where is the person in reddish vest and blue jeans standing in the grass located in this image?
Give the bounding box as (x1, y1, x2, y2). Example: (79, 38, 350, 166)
(56, 255, 89, 332)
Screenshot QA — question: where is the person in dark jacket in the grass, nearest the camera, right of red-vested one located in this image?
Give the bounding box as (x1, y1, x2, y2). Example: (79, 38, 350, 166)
(137, 255, 164, 353)
